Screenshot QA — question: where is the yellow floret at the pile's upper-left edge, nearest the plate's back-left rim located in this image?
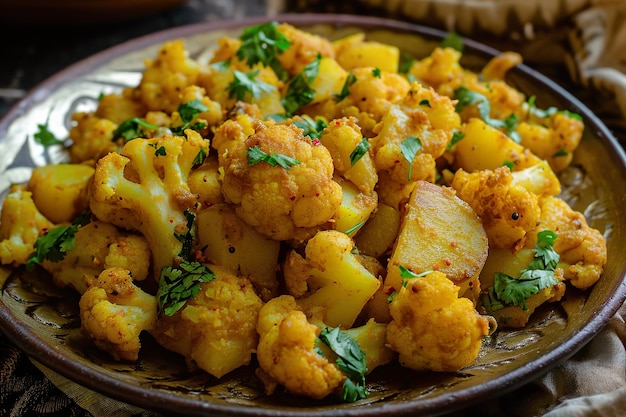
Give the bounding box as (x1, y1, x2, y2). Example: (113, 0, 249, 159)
(137, 40, 200, 113)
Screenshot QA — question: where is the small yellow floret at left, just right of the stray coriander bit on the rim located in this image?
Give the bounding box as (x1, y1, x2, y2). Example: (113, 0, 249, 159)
(69, 112, 118, 164)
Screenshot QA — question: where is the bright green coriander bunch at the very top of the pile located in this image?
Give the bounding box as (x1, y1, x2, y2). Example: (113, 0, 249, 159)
(236, 22, 291, 81)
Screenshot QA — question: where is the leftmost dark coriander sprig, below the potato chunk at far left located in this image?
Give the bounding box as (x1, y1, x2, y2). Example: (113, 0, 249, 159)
(26, 210, 91, 271)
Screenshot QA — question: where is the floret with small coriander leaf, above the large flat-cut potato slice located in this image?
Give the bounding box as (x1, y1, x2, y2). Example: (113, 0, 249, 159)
(371, 83, 460, 193)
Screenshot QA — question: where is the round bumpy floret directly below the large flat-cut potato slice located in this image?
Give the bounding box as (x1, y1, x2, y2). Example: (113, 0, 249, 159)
(387, 272, 489, 372)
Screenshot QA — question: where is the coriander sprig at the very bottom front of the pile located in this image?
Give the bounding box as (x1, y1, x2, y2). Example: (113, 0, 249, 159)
(319, 327, 368, 402)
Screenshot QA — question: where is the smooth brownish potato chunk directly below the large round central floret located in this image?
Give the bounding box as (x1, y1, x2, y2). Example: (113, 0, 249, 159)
(196, 204, 279, 301)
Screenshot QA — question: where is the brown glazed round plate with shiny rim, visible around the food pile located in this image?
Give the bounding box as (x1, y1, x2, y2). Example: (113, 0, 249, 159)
(0, 15, 626, 417)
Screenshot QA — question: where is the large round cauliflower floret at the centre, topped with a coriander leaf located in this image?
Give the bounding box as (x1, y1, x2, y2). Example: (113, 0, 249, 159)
(213, 117, 341, 240)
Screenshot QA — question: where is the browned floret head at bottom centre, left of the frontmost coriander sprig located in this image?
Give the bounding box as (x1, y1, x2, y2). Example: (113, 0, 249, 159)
(257, 295, 344, 399)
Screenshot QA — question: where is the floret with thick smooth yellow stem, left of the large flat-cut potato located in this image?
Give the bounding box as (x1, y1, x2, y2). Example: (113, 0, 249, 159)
(283, 230, 380, 328)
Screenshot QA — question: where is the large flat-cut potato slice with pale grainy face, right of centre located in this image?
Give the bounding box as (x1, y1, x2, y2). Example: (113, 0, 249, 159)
(385, 181, 489, 298)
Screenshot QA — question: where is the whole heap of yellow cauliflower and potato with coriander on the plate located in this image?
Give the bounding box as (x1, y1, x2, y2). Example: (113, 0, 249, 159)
(0, 22, 607, 402)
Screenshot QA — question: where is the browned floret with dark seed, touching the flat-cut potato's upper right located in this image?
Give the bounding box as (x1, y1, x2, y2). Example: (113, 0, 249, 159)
(451, 166, 541, 249)
